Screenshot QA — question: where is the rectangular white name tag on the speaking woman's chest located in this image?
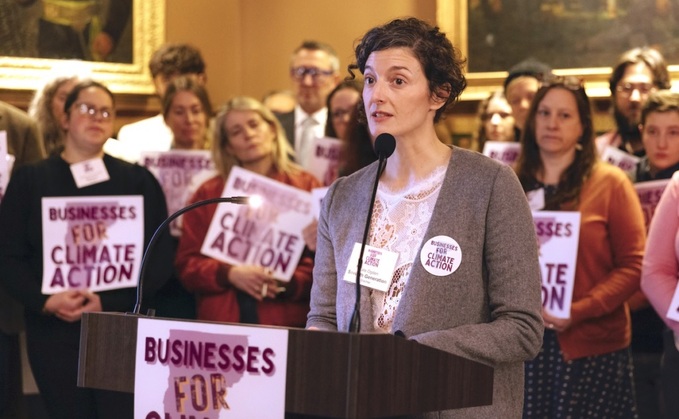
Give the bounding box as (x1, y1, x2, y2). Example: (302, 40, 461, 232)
(344, 243, 398, 292)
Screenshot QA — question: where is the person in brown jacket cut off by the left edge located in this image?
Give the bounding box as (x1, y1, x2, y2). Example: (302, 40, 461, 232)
(0, 102, 45, 418)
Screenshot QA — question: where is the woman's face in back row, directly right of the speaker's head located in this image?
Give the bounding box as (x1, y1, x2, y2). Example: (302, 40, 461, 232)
(475, 90, 514, 151)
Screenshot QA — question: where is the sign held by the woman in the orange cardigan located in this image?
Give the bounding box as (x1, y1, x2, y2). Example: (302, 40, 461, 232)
(533, 211, 580, 319)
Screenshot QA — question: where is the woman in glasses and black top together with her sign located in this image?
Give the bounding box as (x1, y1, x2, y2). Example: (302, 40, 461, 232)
(0, 81, 172, 419)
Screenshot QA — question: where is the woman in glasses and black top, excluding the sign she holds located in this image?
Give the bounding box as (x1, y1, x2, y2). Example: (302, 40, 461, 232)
(0, 81, 173, 419)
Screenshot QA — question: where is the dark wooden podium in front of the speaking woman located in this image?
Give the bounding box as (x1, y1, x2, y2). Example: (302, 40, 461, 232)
(78, 313, 493, 418)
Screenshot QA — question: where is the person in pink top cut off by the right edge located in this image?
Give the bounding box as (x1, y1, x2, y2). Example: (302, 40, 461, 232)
(641, 172, 679, 418)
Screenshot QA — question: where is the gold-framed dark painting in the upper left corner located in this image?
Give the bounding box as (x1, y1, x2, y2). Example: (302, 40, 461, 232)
(0, 0, 165, 94)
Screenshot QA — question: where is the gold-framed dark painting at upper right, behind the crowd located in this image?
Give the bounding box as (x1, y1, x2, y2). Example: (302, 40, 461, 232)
(437, 0, 679, 99)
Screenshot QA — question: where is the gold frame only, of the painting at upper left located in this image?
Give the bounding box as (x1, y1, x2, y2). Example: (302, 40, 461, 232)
(0, 0, 165, 95)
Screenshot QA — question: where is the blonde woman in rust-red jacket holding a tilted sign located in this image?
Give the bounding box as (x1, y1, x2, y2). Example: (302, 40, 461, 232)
(175, 97, 320, 327)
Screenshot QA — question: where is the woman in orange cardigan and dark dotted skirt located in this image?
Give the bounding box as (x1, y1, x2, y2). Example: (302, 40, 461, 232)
(516, 77, 645, 418)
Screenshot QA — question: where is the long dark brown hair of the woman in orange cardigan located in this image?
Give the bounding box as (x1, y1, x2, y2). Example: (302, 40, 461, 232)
(516, 77, 598, 210)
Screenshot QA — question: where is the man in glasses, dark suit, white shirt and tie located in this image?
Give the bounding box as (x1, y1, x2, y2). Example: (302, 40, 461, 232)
(278, 41, 340, 167)
